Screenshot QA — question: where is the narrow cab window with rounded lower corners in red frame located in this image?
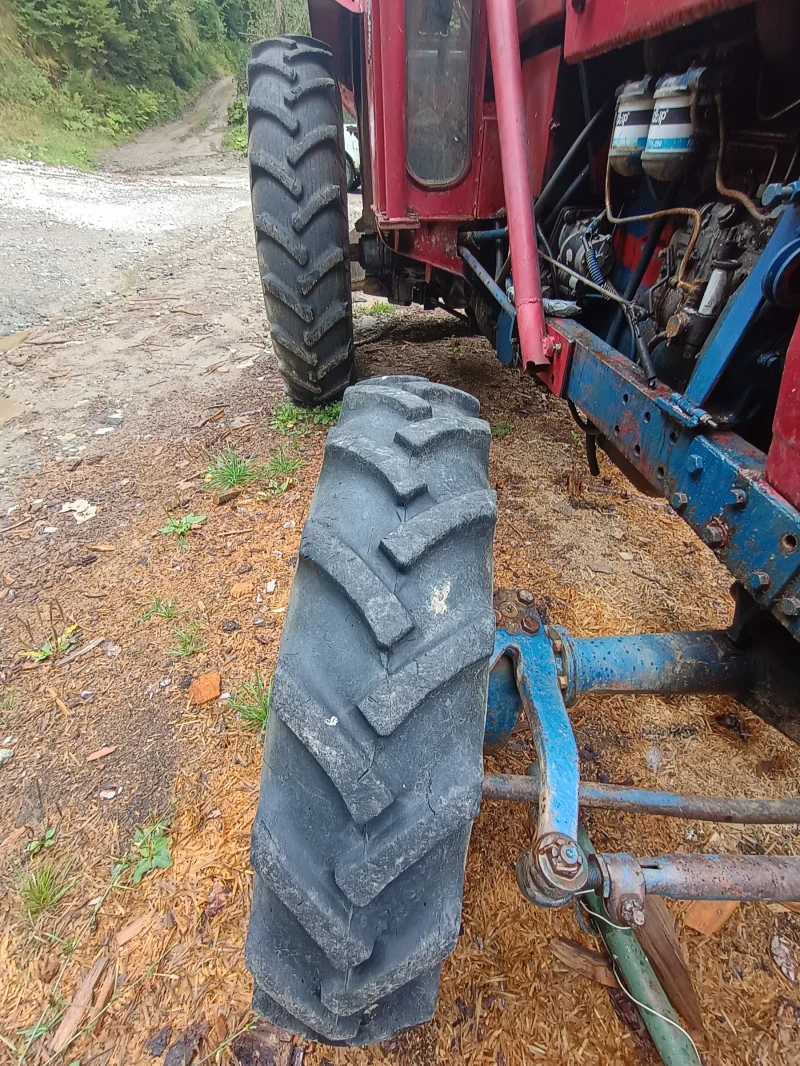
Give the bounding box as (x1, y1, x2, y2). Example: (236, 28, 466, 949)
(405, 0, 473, 185)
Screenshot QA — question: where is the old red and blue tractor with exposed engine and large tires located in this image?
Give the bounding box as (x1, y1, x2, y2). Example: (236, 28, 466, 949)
(246, 0, 800, 1062)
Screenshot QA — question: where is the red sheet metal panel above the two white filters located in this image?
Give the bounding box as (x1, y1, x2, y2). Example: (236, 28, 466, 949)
(564, 0, 748, 63)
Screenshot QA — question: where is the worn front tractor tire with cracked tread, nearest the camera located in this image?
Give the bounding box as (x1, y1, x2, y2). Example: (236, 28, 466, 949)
(246, 376, 497, 1045)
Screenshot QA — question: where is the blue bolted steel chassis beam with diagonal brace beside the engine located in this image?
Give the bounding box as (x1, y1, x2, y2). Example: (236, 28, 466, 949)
(555, 200, 800, 640)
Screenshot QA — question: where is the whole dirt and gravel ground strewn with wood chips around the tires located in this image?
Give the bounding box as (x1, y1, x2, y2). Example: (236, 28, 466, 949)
(0, 89, 800, 1066)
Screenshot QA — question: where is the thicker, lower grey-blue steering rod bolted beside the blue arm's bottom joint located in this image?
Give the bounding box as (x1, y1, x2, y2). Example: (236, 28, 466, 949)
(637, 854, 800, 903)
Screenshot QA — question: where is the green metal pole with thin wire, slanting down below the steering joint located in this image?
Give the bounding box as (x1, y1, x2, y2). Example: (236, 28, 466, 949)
(578, 825, 700, 1066)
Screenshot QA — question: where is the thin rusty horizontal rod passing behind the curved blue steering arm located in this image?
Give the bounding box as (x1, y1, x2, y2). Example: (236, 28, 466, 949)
(482, 774, 800, 825)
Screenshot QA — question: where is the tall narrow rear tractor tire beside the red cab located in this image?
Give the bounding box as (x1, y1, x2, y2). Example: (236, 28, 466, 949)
(247, 36, 354, 406)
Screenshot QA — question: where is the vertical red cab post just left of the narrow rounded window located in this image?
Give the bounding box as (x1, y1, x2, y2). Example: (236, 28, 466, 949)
(381, 0, 406, 220)
